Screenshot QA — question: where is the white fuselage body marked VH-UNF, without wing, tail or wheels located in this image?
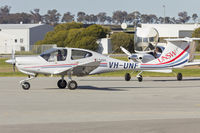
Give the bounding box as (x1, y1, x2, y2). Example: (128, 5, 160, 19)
(15, 48, 141, 75)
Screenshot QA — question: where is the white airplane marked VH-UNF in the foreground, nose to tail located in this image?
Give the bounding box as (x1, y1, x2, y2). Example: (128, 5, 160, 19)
(6, 38, 200, 90)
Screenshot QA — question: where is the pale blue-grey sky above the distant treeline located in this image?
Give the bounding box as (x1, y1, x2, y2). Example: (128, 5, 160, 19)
(0, 0, 200, 17)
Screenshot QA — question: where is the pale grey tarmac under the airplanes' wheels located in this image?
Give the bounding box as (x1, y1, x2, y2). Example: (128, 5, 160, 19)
(0, 77, 200, 133)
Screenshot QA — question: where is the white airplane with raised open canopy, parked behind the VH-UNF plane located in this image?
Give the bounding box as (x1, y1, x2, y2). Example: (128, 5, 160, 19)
(120, 27, 197, 82)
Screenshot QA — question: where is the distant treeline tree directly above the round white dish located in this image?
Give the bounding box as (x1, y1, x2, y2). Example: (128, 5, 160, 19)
(112, 11, 128, 24)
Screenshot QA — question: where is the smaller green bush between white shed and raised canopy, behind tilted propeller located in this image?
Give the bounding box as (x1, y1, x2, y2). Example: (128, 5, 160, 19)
(111, 32, 134, 53)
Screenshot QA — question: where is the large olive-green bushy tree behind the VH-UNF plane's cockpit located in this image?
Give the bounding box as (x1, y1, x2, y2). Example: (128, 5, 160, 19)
(36, 22, 108, 50)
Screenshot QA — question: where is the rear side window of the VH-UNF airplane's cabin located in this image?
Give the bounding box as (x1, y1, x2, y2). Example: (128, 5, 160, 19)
(71, 50, 92, 60)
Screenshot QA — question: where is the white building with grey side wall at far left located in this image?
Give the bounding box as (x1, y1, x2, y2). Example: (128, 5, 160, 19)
(0, 24, 53, 54)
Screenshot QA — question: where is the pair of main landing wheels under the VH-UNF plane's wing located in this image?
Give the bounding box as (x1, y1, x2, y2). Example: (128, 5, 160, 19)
(57, 74, 78, 90)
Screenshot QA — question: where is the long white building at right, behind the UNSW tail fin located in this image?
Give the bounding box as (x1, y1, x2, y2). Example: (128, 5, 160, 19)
(141, 24, 200, 38)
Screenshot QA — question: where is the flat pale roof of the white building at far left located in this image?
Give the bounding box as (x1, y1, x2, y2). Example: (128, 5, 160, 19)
(0, 24, 44, 29)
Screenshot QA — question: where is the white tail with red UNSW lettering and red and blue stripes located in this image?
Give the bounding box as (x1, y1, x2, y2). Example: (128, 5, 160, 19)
(140, 38, 200, 69)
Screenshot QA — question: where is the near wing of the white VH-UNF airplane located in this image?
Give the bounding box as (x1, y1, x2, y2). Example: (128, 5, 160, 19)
(54, 61, 100, 76)
